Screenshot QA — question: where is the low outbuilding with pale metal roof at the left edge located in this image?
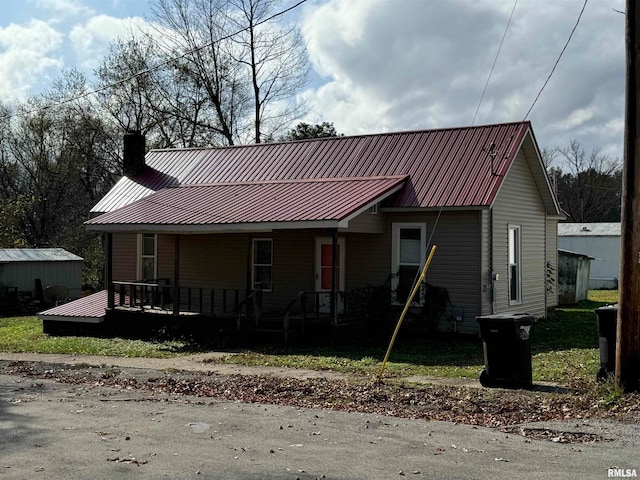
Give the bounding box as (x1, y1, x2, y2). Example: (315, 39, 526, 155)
(0, 248, 83, 310)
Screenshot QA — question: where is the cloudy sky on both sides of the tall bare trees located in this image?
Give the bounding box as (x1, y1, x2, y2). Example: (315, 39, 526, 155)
(0, 0, 625, 160)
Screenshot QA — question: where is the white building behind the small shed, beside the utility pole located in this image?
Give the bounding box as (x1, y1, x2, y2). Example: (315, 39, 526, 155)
(558, 222, 620, 290)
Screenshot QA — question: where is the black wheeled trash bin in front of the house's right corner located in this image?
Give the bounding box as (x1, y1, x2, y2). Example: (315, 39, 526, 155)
(476, 313, 534, 388)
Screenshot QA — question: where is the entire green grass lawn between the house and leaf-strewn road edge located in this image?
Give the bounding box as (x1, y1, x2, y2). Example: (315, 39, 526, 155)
(0, 290, 618, 383)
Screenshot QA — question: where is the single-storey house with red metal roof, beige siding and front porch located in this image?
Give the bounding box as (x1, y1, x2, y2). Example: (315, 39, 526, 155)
(40, 122, 562, 338)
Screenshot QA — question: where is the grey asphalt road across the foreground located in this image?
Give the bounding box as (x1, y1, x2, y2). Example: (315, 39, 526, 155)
(0, 366, 640, 480)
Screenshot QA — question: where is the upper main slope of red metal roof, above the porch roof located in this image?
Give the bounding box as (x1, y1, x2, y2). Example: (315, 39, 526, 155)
(92, 122, 535, 216)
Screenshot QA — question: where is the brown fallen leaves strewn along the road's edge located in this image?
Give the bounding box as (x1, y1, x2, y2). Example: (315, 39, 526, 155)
(0, 362, 640, 434)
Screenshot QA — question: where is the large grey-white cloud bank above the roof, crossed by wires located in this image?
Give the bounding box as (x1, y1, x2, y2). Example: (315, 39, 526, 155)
(302, 0, 624, 157)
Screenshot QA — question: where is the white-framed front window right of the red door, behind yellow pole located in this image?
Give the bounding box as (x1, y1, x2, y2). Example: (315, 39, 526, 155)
(391, 223, 426, 304)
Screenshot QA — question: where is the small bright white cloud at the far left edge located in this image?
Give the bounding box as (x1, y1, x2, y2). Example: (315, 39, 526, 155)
(0, 20, 63, 100)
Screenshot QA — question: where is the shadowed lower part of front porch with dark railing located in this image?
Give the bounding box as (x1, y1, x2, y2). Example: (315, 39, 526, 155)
(104, 274, 364, 345)
